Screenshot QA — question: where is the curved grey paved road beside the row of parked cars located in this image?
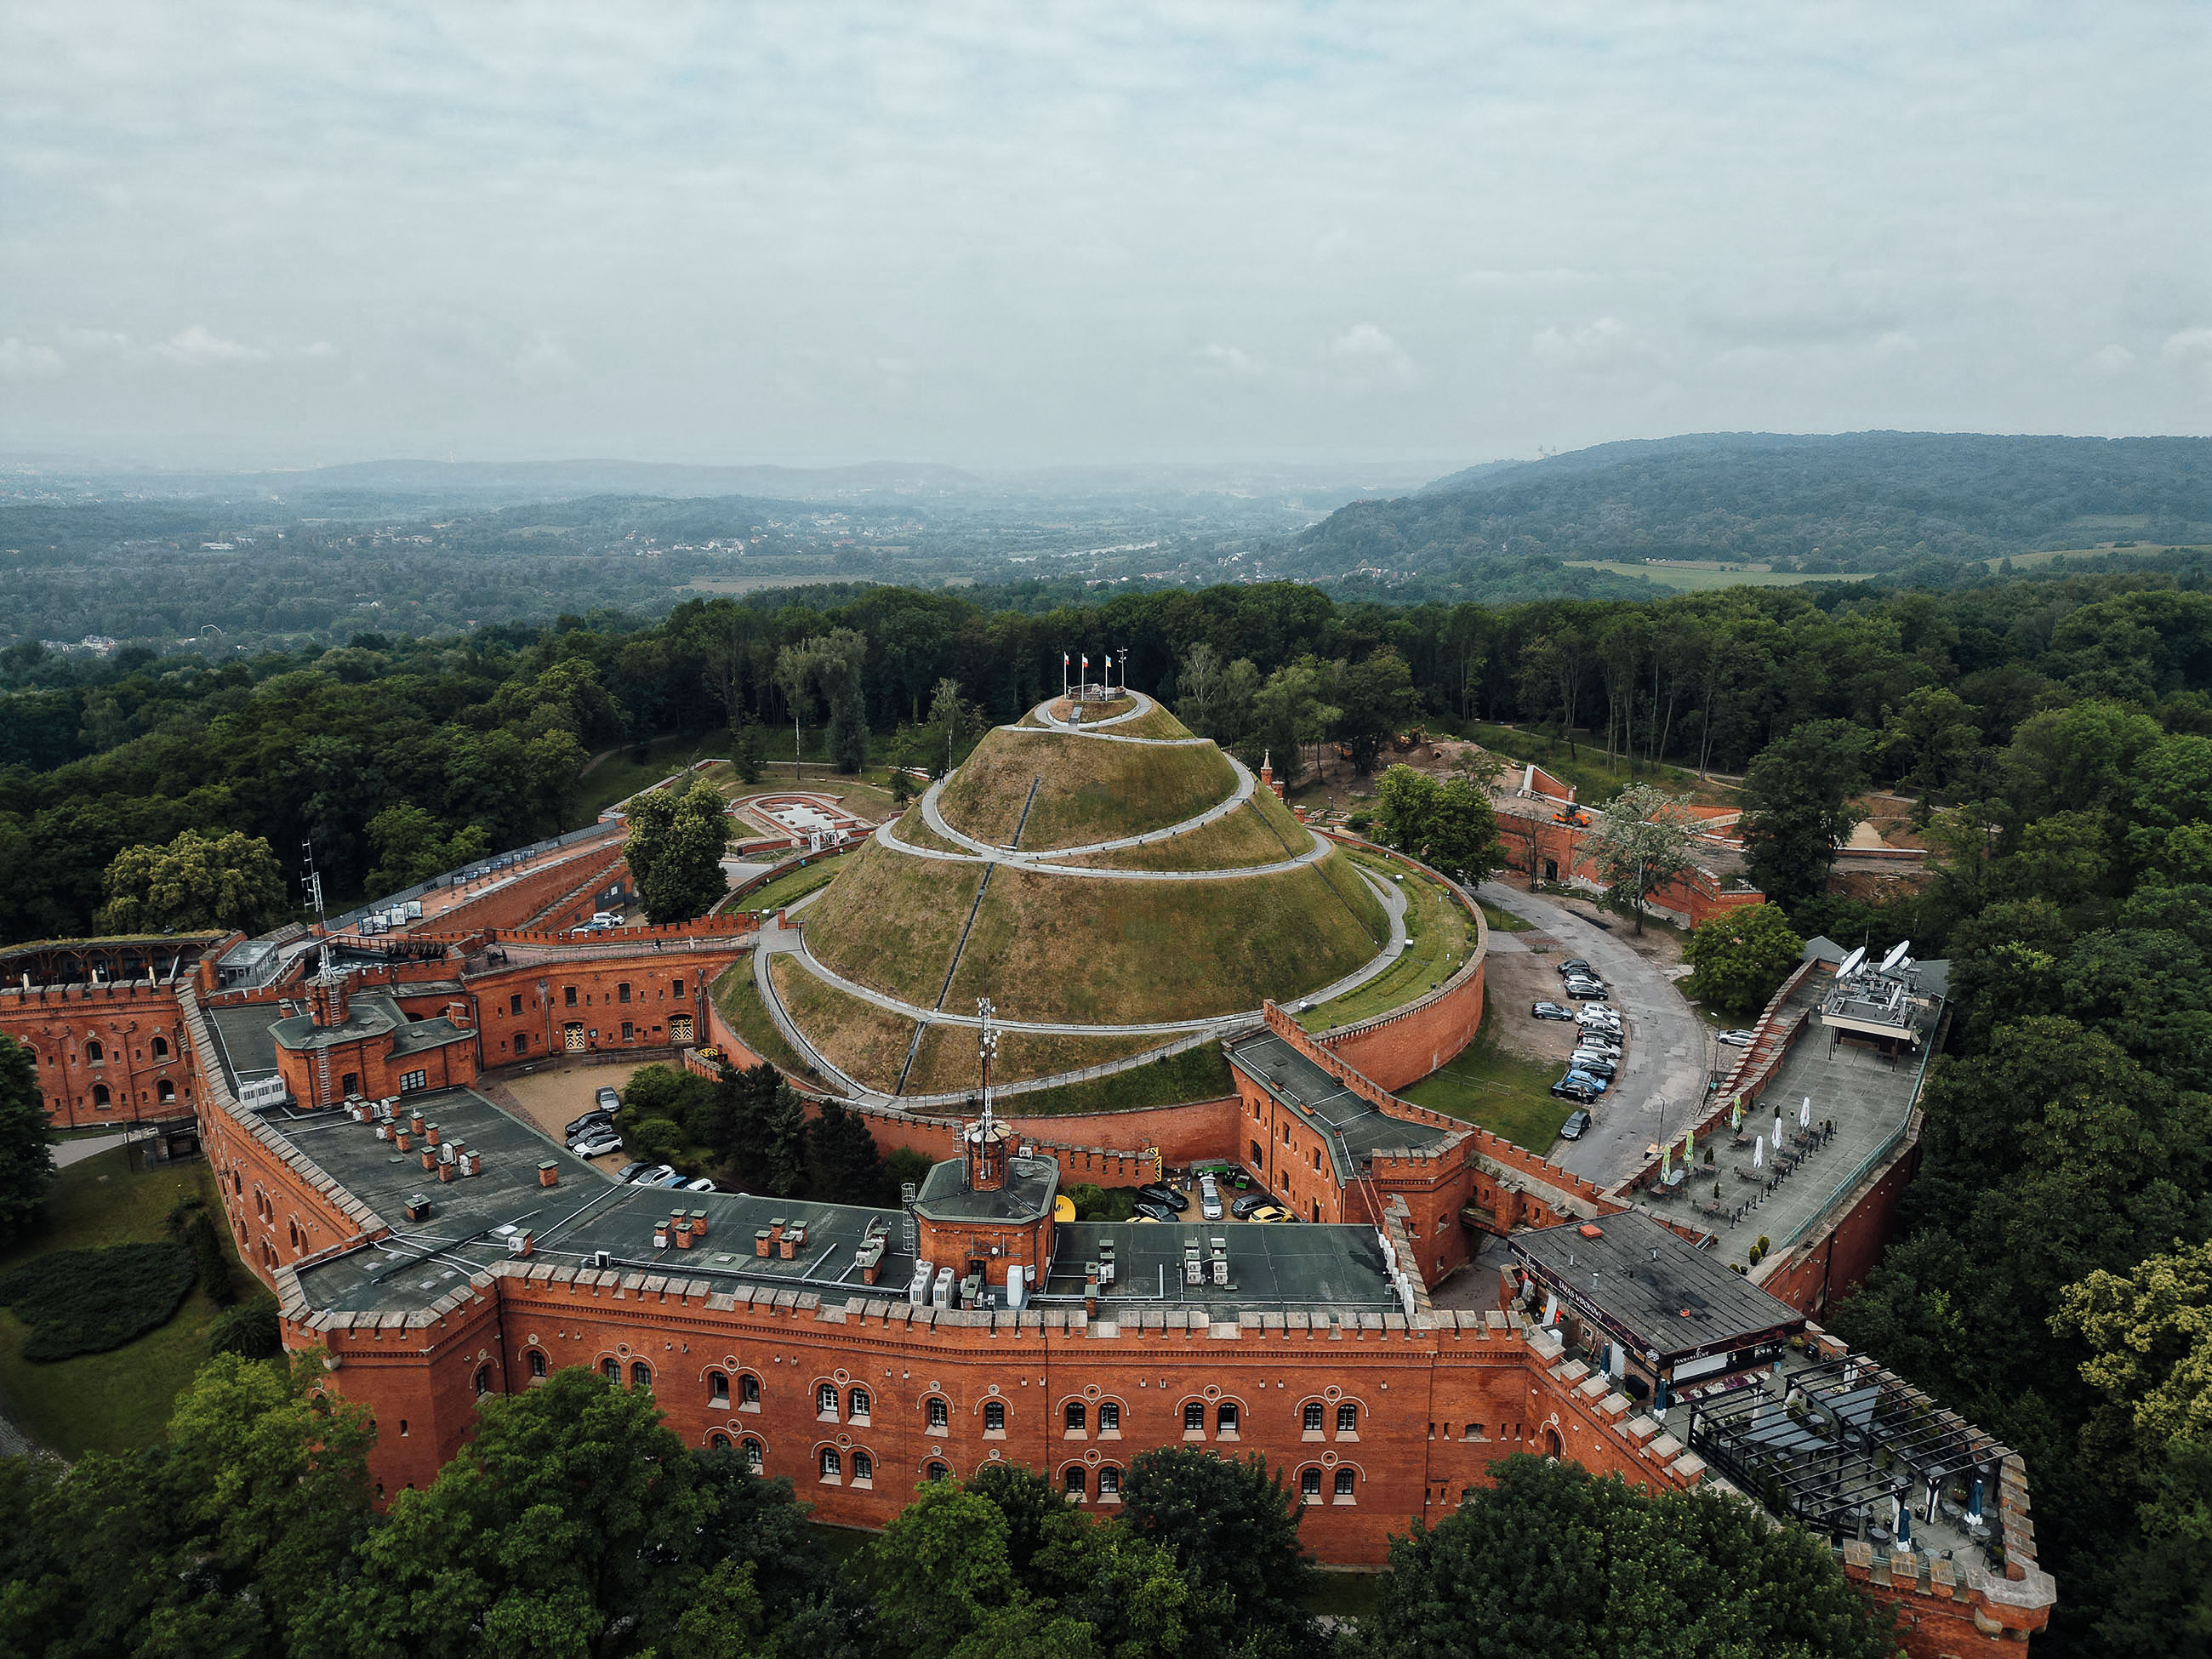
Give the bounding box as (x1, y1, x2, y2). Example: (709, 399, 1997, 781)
(1478, 881, 1714, 1188)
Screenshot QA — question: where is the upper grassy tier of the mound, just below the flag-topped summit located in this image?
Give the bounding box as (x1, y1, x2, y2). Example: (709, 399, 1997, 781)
(938, 726, 1236, 852)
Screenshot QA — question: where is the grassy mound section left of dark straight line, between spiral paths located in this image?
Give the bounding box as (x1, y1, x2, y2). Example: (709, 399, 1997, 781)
(803, 843, 984, 1009)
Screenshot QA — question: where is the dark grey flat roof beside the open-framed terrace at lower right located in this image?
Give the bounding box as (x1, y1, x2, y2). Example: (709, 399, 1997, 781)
(1507, 1210, 1805, 1367)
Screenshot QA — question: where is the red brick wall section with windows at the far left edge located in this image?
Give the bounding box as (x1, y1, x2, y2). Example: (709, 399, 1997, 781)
(0, 984, 195, 1128)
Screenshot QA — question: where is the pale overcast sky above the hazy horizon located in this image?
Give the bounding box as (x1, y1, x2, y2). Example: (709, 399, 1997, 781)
(0, 0, 2212, 467)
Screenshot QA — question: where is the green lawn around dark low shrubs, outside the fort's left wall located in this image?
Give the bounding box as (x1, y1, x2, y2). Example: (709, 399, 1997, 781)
(0, 1148, 246, 1457)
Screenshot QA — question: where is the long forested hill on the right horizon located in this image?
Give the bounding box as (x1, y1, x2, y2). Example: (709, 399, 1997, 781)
(1286, 431, 2212, 586)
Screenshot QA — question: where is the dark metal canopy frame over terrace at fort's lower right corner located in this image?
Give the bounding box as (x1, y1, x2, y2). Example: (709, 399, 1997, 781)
(1688, 1354, 2006, 1537)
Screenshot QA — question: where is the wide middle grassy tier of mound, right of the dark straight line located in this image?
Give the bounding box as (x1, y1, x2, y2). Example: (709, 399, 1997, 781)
(947, 854, 1389, 1024)
